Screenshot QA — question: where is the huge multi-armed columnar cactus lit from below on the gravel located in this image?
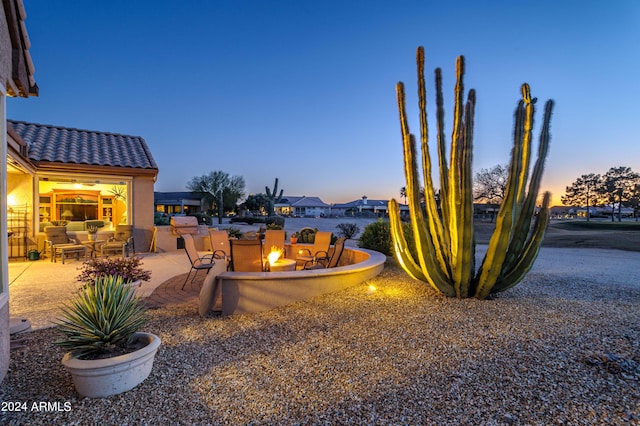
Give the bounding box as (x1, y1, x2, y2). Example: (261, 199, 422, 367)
(389, 47, 553, 299)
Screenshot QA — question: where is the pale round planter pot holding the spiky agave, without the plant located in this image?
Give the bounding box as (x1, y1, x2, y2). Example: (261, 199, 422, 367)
(62, 333, 160, 398)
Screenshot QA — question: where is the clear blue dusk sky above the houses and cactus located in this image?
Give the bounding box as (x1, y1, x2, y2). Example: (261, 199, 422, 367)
(7, 0, 640, 203)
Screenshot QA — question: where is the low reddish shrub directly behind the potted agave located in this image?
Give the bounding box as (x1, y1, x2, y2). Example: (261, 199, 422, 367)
(76, 257, 151, 287)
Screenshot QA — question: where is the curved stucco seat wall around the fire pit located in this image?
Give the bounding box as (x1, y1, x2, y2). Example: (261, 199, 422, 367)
(218, 247, 386, 315)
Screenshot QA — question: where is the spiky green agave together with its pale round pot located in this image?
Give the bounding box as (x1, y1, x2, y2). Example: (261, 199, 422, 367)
(55, 275, 160, 398)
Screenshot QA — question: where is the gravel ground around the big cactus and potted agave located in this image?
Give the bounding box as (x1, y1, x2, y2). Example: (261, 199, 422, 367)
(0, 249, 640, 425)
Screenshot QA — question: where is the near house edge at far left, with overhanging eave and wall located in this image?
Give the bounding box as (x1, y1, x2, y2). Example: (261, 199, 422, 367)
(0, 0, 38, 380)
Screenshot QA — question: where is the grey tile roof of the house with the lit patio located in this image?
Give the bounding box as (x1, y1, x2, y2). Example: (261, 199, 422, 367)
(7, 120, 158, 170)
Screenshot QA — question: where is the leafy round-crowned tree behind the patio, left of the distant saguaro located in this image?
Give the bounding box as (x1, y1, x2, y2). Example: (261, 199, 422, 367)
(187, 170, 245, 223)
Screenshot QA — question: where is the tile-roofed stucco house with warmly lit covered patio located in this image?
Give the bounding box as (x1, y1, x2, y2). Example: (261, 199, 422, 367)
(7, 120, 158, 257)
